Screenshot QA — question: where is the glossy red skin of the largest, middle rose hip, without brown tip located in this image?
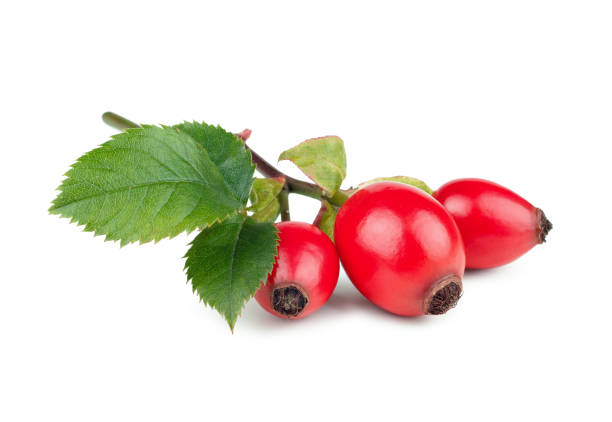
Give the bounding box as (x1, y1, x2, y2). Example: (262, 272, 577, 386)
(334, 182, 465, 316)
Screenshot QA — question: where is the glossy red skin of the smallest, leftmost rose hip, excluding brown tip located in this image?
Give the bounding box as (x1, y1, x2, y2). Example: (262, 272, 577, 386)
(255, 221, 340, 319)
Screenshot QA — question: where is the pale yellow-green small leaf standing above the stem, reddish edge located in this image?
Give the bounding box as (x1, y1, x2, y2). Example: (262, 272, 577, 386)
(278, 136, 346, 196)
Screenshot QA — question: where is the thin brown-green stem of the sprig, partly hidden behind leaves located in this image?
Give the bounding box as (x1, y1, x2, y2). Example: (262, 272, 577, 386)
(102, 111, 349, 206)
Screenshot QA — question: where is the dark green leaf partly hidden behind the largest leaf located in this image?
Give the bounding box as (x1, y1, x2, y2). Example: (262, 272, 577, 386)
(174, 122, 255, 204)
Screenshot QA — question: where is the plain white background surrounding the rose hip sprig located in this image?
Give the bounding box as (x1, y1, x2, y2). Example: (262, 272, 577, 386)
(0, 0, 612, 422)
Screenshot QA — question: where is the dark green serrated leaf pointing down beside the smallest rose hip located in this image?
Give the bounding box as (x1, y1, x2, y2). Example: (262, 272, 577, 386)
(185, 215, 278, 331)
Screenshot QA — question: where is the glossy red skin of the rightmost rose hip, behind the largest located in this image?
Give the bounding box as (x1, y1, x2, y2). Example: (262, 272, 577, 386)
(434, 179, 539, 268)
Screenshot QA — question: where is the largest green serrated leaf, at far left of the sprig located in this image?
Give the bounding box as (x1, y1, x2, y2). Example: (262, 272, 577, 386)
(49, 126, 246, 246)
